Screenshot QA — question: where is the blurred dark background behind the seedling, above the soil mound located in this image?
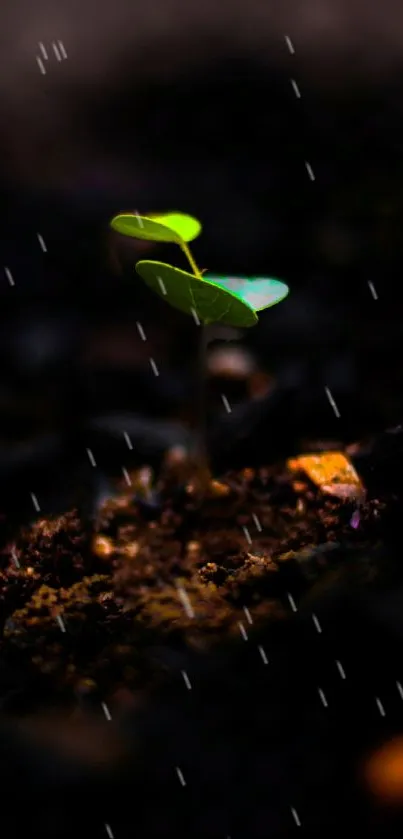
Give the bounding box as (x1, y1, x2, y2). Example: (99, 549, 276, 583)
(0, 0, 403, 509)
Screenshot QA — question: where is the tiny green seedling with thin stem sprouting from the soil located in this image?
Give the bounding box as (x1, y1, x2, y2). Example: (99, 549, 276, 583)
(111, 212, 288, 486)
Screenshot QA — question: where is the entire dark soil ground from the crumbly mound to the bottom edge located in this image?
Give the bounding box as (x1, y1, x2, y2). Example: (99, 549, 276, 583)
(0, 456, 403, 839)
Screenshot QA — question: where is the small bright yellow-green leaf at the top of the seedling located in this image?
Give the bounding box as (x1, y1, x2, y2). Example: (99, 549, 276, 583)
(111, 213, 202, 245)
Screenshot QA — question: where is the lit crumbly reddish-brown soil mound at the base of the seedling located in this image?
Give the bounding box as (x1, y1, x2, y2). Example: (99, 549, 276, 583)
(1, 455, 392, 701)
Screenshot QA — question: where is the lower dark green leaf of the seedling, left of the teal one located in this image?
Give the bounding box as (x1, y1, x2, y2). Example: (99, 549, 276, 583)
(136, 260, 257, 327)
